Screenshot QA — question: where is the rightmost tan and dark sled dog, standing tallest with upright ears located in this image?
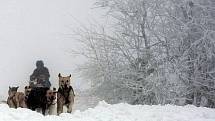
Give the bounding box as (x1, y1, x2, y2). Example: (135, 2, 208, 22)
(57, 73, 75, 115)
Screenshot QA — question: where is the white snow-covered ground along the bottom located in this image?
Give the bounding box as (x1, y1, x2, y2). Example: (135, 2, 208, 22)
(0, 101, 215, 121)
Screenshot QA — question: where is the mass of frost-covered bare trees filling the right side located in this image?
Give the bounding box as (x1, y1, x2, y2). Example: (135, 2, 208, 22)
(73, 0, 215, 106)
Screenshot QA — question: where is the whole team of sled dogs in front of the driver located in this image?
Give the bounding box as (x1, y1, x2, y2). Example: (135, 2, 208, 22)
(7, 73, 75, 115)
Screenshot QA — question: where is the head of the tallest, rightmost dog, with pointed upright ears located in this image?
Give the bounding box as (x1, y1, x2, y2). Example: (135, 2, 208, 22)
(58, 73, 71, 88)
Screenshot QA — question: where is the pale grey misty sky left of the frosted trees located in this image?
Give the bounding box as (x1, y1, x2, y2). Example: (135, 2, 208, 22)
(0, 0, 100, 99)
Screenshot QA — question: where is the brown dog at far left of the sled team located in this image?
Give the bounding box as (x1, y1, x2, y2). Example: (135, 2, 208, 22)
(7, 87, 27, 108)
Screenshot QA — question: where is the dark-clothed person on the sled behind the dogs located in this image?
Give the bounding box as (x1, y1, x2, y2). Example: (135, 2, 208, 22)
(29, 60, 51, 88)
